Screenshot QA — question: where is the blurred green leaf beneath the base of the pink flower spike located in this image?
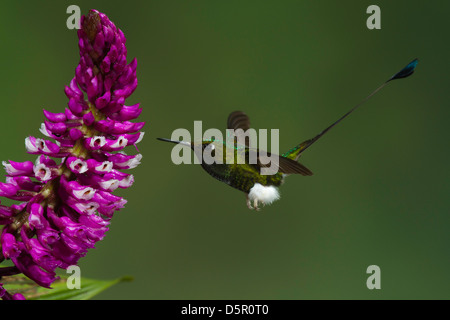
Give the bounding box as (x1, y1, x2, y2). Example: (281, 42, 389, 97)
(1, 275, 133, 300)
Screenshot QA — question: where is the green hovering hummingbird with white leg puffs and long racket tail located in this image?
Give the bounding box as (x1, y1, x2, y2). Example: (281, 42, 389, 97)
(157, 59, 418, 211)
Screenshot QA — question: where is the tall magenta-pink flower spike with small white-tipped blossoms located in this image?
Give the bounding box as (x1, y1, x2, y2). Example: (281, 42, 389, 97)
(0, 10, 144, 300)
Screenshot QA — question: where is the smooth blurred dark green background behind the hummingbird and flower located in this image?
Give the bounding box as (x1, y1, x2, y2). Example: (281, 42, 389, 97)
(0, 0, 450, 299)
